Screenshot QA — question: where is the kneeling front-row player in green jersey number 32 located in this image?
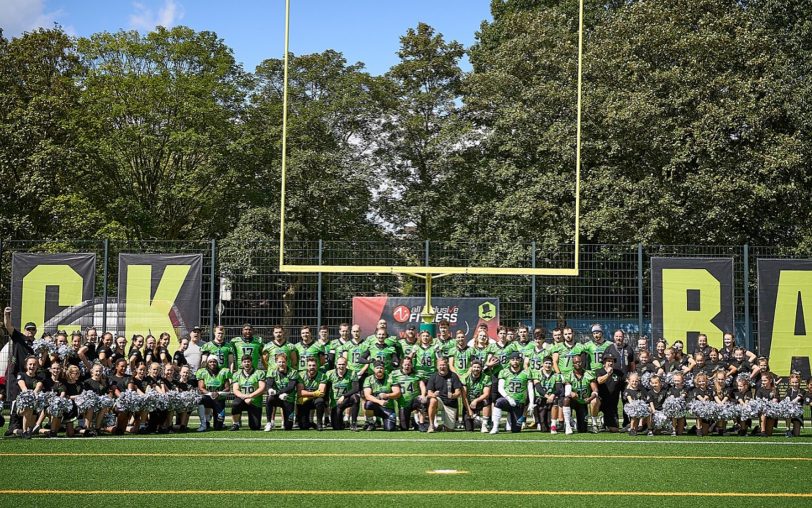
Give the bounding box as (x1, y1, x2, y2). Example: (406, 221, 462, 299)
(491, 351, 536, 434)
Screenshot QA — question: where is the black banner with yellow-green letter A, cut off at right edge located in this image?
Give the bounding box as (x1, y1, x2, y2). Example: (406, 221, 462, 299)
(758, 259, 812, 379)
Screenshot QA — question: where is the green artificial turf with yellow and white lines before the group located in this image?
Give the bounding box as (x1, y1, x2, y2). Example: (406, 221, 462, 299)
(0, 430, 812, 508)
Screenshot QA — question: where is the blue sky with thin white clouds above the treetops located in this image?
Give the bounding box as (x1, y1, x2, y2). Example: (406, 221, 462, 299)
(0, 0, 491, 74)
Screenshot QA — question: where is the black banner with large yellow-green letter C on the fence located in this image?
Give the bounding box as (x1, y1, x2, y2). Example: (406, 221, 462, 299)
(11, 252, 96, 336)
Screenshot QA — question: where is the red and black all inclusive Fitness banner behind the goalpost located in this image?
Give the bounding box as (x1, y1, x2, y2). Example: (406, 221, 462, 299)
(352, 296, 499, 339)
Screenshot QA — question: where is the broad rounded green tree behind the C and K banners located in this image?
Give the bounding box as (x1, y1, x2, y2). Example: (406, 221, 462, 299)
(78, 26, 251, 239)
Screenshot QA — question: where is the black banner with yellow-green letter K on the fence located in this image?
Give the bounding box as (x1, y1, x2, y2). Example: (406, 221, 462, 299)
(118, 254, 203, 351)
